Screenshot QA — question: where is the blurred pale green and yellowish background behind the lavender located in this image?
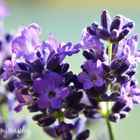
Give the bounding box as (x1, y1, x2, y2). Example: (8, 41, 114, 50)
(5, 0, 140, 140)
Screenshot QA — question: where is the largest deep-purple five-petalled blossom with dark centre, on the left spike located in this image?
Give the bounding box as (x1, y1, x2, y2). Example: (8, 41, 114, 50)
(33, 72, 69, 109)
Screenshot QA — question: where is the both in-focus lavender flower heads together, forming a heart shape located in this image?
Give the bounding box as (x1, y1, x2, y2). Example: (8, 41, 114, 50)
(0, 11, 140, 140)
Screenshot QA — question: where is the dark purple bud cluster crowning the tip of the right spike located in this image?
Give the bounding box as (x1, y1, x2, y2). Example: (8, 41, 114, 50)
(87, 10, 134, 43)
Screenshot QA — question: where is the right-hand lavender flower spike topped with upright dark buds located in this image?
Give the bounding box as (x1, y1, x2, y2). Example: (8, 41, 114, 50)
(78, 11, 140, 122)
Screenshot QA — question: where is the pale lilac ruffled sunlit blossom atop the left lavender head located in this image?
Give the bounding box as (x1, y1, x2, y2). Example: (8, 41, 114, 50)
(12, 24, 41, 61)
